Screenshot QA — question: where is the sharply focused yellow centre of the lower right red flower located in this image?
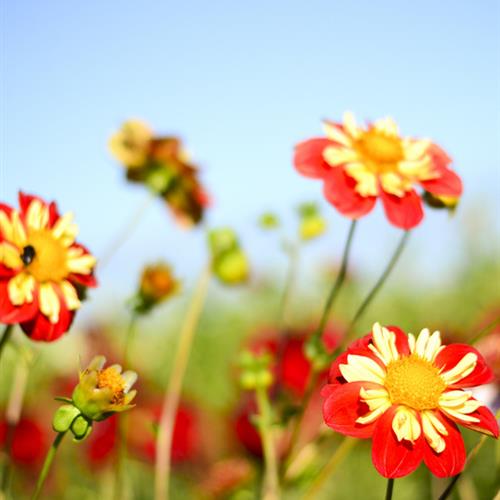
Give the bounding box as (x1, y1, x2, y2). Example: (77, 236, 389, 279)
(385, 354, 446, 410)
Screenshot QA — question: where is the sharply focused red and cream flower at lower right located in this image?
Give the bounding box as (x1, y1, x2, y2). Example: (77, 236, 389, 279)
(322, 323, 498, 478)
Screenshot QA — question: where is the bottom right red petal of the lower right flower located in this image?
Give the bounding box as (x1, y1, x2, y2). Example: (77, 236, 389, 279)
(424, 412, 466, 477)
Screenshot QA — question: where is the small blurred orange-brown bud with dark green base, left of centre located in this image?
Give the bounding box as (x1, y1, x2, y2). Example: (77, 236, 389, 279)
(133, 262, 180, 313)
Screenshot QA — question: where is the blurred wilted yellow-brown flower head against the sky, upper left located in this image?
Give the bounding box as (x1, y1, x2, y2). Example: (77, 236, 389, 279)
(109, 120, 210, 226)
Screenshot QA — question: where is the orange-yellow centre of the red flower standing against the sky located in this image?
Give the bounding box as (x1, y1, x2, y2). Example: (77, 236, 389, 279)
(354, 129, 404, 173)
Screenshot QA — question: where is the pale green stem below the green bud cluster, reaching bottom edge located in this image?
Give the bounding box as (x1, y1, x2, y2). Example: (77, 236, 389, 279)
(256, 387, 280, 500)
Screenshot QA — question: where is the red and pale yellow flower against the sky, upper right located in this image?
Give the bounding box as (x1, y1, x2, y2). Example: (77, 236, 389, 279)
(294, 113, 462, 229)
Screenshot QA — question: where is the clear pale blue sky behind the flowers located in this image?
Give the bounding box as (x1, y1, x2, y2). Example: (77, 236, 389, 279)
(0, 0, 500, 300)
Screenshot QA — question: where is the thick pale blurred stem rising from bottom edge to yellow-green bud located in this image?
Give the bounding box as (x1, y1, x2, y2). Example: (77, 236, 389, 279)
(155, 265, 211, 500)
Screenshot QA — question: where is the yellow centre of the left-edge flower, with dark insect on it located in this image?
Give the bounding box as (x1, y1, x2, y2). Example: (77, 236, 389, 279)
(21, 229, 69, 282)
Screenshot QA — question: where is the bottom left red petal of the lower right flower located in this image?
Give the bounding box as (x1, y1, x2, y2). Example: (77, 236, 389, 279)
(372, 405, 424, 478)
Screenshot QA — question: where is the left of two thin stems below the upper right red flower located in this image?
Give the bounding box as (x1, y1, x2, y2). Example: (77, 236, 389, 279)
(286, 220, 357, 464)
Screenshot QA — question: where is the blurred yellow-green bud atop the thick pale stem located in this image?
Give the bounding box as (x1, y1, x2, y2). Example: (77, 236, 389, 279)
(208, 228, 250, 285)
